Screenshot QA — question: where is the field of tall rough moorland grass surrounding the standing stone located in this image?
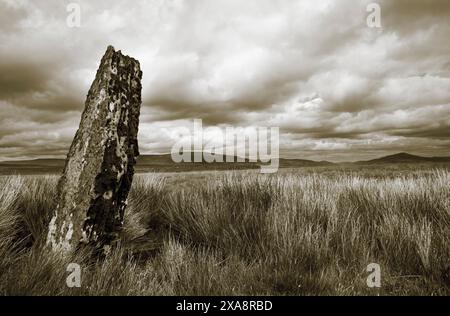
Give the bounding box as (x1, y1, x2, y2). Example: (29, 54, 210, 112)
(0, 167, 450, 295)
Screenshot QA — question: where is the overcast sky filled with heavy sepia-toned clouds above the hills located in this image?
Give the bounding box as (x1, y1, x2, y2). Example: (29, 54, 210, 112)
(0, 0, 450, 161)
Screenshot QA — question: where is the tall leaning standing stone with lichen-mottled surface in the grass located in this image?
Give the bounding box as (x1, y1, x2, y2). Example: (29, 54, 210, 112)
(47, 46, 142, 252)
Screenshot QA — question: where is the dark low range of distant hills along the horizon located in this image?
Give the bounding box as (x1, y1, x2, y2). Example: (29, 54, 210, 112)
(0, 153, 450, 174)
